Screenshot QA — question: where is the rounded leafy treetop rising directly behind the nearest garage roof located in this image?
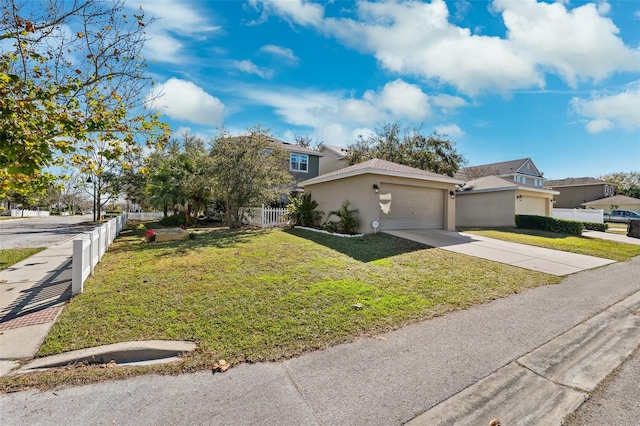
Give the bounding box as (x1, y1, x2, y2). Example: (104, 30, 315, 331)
(348, 122, 464, 176)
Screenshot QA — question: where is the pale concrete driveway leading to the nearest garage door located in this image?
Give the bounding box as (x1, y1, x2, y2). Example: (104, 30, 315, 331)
(384, 229, 615, 276)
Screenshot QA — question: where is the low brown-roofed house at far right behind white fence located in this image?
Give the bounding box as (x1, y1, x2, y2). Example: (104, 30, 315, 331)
(544, 177, 615, 209)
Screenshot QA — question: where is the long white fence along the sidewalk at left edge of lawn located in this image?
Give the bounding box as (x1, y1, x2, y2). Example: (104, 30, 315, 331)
(71, 213, 129, 296)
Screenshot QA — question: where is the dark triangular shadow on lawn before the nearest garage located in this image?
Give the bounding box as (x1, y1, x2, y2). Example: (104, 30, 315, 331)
(285, 228, 431, 263)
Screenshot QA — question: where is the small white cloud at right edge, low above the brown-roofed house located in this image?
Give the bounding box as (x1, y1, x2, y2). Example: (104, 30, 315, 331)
(571, 88, 640, 133)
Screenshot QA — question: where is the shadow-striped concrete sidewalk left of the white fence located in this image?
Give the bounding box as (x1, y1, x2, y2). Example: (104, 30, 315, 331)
(0, 237, 75, 375)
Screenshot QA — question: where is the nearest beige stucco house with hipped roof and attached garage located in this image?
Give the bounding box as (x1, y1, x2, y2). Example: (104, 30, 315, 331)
(300, 159, 464, 233)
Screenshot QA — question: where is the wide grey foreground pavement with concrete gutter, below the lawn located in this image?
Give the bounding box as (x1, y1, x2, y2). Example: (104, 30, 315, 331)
(0, 257, 640, 426)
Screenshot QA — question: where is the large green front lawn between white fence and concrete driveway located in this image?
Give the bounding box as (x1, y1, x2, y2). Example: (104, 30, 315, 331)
(0, 225, 560, 390)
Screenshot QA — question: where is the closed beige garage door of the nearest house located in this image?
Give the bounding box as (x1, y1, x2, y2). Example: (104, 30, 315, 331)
(380, 183, 444, 230)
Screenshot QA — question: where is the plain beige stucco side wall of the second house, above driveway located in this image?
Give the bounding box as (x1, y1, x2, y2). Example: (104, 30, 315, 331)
(456, 191, 516, 228)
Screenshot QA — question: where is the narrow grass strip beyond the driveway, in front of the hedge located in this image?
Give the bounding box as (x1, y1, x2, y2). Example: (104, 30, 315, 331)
(464, 228, 640, 262)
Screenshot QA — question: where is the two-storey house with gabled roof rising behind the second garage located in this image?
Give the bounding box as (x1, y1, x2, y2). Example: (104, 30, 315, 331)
(455, 158, 544, 188)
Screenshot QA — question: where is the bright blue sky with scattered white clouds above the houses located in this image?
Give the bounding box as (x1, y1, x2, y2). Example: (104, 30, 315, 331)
(132, 0, 640, 179)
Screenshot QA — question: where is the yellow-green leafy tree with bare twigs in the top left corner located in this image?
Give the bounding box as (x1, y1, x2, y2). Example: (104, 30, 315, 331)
(0, 0, 167, 200)
